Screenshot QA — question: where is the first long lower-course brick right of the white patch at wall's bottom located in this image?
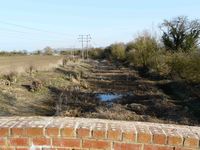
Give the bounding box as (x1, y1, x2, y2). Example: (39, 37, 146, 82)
(52, 138, 81, 147)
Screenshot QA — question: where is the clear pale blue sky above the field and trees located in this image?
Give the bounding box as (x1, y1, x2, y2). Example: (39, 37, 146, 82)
(0, 0, 200, 50)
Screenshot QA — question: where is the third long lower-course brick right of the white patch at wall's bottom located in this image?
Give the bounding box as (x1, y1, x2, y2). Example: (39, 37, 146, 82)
(114, 143, 142, 150)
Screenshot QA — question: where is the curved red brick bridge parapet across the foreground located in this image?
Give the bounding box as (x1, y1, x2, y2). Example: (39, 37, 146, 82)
(0, 117, 200, 150)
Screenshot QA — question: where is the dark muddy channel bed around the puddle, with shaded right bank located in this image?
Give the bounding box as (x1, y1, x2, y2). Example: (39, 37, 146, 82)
(55, 61, 200, 125)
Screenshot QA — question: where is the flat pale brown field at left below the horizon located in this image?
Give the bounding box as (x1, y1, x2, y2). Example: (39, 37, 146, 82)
(0, 56, 62, 74)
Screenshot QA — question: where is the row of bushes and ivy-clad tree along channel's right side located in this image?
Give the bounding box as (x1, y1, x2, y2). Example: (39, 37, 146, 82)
(89, 16, 200, 83)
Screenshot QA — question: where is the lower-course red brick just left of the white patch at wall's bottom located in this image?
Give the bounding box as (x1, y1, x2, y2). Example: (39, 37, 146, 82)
(9, 138, 29, 146)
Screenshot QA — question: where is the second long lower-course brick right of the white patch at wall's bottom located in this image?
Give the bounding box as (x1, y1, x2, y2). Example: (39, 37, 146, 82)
(83, 140, 111, 149)
